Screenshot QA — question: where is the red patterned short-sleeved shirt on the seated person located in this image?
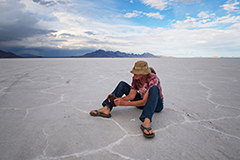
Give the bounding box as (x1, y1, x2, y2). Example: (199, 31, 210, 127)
(131, 73, 163, 102)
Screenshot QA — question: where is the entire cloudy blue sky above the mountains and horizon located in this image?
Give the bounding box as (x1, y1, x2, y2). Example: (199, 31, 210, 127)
(0, 0, 240, 57)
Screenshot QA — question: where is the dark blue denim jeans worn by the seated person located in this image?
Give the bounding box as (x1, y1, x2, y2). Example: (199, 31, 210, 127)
(102, 81, 163, 122)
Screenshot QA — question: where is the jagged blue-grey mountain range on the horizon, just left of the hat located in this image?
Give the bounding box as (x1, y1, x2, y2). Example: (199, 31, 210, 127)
(76, 49, 159, 58)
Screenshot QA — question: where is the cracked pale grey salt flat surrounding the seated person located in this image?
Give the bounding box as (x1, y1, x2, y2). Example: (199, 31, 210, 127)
(0, 58, 240, 160)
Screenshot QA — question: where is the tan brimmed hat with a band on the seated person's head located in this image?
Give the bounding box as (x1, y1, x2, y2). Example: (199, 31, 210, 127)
(130, 61, 151, 75)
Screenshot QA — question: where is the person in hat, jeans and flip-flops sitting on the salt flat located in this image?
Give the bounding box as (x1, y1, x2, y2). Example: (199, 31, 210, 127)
(90, 61, 163, 138)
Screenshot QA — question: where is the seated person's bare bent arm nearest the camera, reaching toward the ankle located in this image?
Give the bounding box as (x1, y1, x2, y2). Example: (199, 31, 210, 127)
(114, 91, 148, 107)
